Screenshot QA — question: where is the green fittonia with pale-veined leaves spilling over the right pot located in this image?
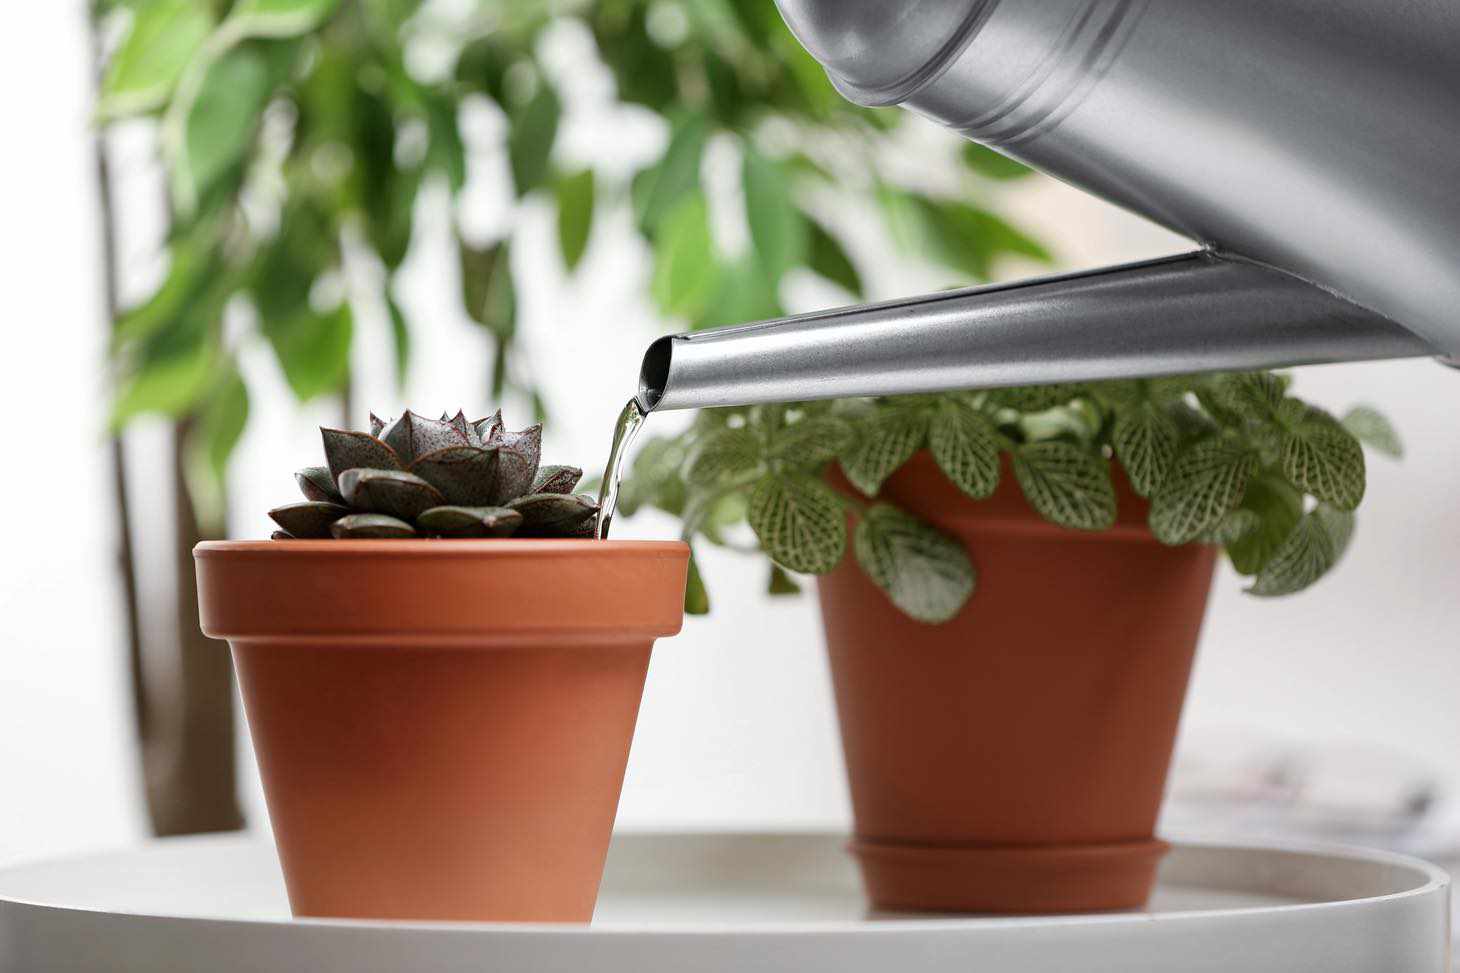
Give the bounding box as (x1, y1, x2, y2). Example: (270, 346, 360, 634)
(619, 373, 1402, 622)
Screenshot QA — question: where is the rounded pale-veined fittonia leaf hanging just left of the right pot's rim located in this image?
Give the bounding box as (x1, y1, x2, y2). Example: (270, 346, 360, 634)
(746, 475, 847, 574)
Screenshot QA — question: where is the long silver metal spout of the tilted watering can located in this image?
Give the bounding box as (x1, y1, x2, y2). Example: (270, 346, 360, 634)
(638, 251, 1434, 412)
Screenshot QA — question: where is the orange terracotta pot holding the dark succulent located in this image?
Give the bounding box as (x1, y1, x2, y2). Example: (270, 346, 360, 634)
(194, 541, 689, 922)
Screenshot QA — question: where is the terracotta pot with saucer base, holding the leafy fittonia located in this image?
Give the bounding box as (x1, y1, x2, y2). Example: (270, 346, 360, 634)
(819, 453, 1215, 913)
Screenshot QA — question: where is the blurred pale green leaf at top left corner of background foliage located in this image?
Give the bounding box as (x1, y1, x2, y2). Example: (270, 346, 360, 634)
(98, 0, 213, 118)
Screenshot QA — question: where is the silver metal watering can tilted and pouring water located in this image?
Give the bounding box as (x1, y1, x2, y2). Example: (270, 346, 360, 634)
(638, 0, 1460, 412)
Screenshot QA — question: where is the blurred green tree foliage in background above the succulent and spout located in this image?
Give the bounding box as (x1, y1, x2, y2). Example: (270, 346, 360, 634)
(98, 0, 1047, 493)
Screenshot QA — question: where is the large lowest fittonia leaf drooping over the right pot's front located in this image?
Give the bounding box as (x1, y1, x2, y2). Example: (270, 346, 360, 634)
(853, 504, 974, 622)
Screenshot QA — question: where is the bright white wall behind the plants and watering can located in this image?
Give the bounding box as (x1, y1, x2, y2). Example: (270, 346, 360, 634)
(0, 3, 1460, 858)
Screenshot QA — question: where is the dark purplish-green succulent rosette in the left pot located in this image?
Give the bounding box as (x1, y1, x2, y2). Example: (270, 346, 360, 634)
(269, 409, 599, 539)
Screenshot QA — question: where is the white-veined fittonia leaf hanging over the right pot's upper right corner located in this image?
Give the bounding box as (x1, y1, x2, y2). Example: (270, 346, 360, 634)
(1150, 440, 1257, 543)
